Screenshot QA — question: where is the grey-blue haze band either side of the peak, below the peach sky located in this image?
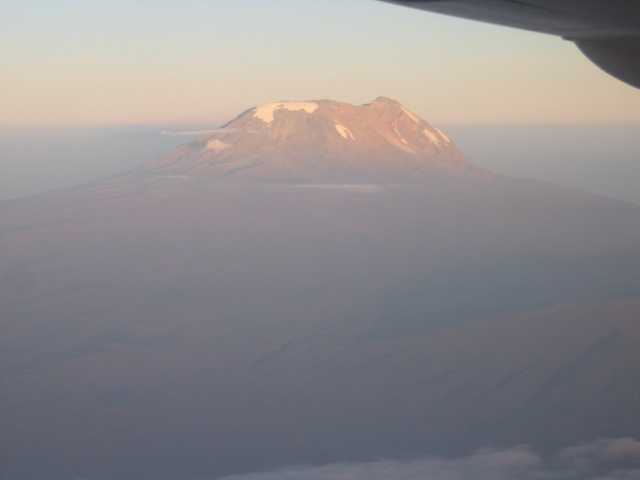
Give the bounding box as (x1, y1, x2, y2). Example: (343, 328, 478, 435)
(0, 120, 640, 204)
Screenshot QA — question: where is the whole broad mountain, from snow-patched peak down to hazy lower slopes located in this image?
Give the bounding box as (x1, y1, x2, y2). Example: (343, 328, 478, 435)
(0, 99, 640, 480)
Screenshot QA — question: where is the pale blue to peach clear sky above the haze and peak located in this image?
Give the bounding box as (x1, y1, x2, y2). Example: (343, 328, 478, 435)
(0, 0, 640, 126)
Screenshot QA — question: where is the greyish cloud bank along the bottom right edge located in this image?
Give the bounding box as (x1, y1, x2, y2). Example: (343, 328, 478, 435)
(218, 438, 640, 480)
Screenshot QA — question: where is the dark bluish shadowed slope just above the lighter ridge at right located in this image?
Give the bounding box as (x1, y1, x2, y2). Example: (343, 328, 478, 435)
(372, 253, 640, 338)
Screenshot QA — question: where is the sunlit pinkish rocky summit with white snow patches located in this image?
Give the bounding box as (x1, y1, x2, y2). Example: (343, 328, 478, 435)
(145, 97, 482, 184)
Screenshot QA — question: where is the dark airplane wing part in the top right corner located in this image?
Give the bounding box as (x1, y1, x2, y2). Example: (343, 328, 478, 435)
(383, 0, 640, 88)
